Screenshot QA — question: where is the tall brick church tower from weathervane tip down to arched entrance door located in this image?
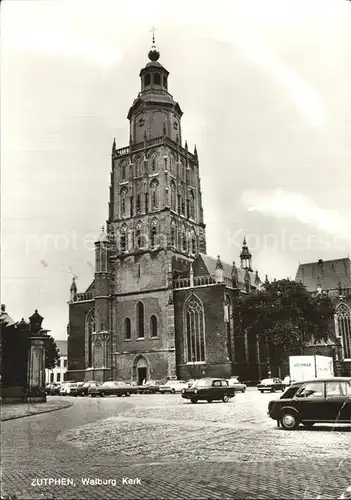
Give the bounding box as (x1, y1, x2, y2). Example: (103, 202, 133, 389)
(104, 36, 206, 382)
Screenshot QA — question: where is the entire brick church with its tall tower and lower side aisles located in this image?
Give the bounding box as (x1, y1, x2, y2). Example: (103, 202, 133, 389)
(67, 39, 263, 383)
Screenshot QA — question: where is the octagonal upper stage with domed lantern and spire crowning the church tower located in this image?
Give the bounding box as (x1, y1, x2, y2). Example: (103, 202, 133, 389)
(128, 29, 183, 144)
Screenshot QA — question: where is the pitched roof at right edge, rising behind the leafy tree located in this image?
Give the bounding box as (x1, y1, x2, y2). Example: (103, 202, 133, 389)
(295, 257, 351, 292)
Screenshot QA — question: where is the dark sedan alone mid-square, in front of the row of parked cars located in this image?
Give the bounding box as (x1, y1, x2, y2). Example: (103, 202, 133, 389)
(182, 378, 235, 403)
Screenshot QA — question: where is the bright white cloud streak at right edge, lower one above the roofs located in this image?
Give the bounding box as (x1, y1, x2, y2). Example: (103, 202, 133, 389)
(242, 188, 351, 238)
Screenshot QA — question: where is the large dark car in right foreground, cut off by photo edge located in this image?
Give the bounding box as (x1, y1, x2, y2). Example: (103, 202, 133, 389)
(268, 377, 351, 430)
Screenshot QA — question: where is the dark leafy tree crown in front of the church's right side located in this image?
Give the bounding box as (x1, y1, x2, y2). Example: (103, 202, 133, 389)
(233, 279, 334, 358)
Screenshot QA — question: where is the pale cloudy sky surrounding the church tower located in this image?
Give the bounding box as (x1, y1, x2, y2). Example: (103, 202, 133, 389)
(1, 0, 351, 340)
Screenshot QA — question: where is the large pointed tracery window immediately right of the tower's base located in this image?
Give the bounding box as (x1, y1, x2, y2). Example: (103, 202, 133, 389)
(184, 295, 206, 363)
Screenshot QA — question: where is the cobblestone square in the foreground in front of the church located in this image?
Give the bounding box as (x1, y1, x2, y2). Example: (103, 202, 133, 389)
(2, 390, 351, 499)
